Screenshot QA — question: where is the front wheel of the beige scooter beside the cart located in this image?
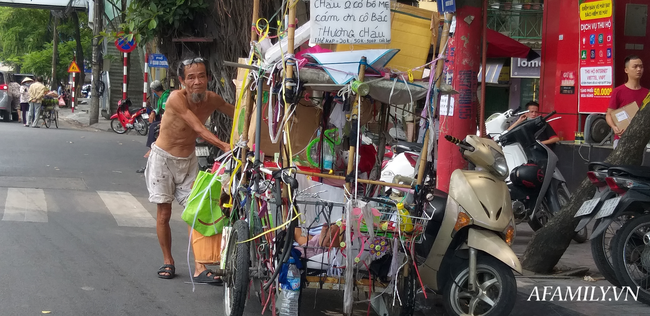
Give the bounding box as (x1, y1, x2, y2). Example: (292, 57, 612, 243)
(443, 255, 517, 316)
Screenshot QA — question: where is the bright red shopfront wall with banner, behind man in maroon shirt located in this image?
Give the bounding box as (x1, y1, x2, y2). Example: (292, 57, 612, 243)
(540, 0, 650, 140)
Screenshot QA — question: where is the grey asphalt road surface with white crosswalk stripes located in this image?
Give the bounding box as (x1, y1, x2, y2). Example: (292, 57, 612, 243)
(0, 117, 647, 316)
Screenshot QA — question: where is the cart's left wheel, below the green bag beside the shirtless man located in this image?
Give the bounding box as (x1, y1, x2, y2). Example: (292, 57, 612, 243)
(224, 220, 250, 316)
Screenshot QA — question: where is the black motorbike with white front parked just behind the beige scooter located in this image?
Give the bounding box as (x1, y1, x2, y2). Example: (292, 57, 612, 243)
(485, 110, 588, 243)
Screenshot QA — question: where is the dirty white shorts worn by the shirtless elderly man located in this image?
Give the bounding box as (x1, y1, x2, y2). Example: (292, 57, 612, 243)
(144, 144, 199, 207)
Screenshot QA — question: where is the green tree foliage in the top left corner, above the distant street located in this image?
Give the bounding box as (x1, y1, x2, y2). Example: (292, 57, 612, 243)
(0, 7, 92, 78)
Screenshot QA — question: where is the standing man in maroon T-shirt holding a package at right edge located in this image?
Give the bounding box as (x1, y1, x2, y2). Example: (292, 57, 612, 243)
(605, 55, 648, 148)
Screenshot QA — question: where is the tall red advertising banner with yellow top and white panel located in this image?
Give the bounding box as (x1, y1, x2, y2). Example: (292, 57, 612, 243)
(578, 0, 614, 113)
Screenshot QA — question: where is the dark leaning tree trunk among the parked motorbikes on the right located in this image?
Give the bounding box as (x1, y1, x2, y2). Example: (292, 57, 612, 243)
(522, 102, 650, 273)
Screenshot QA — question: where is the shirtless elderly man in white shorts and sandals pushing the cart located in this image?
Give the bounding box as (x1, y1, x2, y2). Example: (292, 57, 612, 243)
(145, 58, 235, 283)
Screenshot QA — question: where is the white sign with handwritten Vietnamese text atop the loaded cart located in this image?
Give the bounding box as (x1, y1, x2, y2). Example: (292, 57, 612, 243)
(310, 0, 391, 44)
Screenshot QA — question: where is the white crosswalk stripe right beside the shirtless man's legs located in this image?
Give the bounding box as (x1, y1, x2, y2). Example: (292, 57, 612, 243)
(97, 191, 156, 227)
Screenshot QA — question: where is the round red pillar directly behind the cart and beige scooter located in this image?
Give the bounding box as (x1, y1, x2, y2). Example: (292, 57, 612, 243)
(436, 0, 483, 192)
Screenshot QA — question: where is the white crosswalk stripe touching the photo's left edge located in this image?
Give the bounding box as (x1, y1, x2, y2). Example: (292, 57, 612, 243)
(2, 188, 47, 223)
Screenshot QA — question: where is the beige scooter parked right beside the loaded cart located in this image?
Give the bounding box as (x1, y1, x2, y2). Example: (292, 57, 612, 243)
(415, 135, 522, 315)
